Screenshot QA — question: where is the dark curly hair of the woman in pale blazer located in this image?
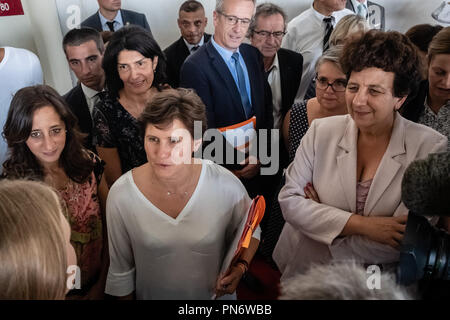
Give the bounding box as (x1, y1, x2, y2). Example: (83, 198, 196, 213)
(340, 30, 421, 97)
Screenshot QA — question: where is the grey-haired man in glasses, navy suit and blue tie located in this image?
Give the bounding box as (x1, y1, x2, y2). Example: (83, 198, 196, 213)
(180, 0, 273, 196)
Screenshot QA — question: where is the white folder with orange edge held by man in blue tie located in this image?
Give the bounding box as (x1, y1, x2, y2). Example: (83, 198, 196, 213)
(218, 116, 256, 152)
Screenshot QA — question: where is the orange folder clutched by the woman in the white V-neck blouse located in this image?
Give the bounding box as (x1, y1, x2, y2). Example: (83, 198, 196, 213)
(220, 196, 266, 274)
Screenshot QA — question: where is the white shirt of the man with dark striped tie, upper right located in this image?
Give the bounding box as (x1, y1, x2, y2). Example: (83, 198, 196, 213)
(281, 5, 354, 102)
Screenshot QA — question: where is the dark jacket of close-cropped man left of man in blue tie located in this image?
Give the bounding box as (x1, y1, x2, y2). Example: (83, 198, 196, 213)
(164, 33, 211, 88)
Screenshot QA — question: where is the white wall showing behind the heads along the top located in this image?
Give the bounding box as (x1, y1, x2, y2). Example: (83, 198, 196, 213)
(0, 0, 448, 94)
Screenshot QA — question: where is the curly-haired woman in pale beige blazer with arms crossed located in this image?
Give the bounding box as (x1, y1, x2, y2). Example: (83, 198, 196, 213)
(274, 30, 447, 280)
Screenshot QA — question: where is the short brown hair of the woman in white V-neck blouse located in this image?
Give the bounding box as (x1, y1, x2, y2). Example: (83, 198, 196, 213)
(139, 88, 207, 139)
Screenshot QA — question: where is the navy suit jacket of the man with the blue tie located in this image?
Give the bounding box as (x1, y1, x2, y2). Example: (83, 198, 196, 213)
(180, 41, 273, 129)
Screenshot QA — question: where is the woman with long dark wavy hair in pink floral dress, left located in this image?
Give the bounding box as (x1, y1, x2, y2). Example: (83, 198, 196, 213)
(3, 85, 108, 299)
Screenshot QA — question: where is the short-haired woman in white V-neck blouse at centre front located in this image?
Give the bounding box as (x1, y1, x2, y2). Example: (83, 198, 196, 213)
(106, 89, 260, 299)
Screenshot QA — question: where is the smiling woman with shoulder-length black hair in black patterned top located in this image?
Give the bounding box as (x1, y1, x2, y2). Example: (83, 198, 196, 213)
(93, 26, 167, 186)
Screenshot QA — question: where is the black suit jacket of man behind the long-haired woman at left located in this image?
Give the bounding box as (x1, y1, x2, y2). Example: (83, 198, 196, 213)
(63, 84, 96, 152)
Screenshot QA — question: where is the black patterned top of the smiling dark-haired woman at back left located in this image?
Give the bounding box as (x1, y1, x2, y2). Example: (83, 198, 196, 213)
(92, 94, 147, 173)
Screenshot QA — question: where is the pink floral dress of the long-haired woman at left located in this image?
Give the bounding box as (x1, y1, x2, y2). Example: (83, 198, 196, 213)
(58, 152, 104, 291)
